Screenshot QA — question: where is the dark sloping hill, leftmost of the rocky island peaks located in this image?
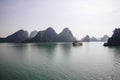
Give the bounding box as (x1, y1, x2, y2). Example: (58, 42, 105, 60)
(4, 30, 28, 42)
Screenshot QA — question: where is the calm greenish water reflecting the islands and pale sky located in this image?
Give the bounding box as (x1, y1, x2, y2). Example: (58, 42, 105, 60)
(0, 42, 120, 80)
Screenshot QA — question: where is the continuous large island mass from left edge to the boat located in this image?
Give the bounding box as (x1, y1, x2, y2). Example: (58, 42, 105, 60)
(0, 27, 76, 43)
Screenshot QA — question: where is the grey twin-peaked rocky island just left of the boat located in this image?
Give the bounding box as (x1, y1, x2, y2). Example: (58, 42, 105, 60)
(30, 27, 75, 42)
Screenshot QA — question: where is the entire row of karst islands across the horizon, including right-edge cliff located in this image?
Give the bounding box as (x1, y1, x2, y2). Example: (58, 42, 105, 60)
(0, 27, 120, 46)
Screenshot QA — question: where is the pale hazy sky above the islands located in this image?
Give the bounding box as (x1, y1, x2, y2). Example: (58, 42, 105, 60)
(0, 0, 120, 39)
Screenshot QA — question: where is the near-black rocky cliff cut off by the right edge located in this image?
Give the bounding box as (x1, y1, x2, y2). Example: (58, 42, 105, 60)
(104, 28, 120, 46)
